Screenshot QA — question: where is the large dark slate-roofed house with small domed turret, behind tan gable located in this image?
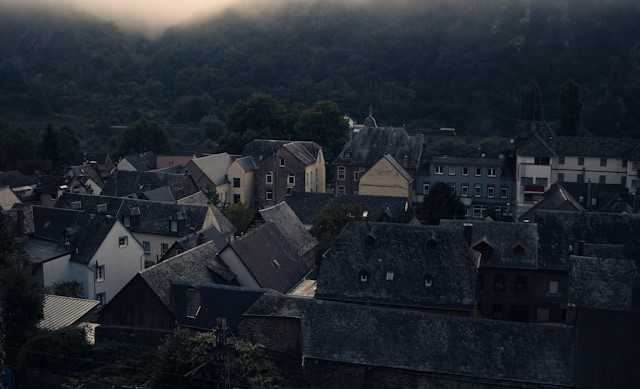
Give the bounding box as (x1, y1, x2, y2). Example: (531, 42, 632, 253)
(332, 126, 424, 196)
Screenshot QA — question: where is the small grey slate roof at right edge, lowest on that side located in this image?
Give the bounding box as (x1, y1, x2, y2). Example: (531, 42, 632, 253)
(569, 256, 640, 310)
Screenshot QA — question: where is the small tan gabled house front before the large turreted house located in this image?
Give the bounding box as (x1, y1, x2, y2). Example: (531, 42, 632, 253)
(358, 154, 413, 199)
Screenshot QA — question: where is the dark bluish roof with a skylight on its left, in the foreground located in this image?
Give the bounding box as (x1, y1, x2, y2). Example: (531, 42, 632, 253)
(172, 283, 267, 330)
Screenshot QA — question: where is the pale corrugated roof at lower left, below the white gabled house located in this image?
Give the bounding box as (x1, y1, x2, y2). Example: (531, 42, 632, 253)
(38, 294, 100, 331)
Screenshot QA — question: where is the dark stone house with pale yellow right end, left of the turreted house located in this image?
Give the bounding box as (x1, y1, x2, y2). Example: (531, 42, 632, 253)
(243, 139, 326, 208)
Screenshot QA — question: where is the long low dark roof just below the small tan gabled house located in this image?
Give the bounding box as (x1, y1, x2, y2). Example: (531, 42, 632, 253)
(285, 192, 409, 225)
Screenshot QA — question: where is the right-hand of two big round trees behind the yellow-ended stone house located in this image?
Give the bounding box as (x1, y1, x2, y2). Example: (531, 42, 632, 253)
(295, 101, 349, 160)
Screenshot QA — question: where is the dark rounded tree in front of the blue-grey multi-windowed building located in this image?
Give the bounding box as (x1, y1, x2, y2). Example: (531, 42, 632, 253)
(418, 183, 465, 224)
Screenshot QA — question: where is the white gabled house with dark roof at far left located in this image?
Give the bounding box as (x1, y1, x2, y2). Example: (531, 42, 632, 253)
(24, 206, 145, 304)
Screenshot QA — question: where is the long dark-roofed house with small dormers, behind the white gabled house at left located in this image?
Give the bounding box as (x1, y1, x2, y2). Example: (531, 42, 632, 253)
(56, 193, 228, 264)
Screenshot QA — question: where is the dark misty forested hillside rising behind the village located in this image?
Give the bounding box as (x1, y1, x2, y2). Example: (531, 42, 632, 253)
(0, 0, 640, 136)
